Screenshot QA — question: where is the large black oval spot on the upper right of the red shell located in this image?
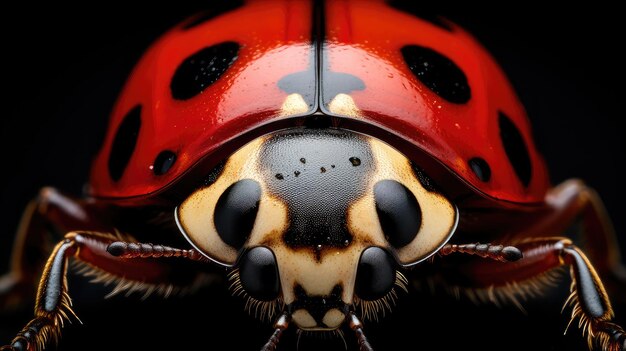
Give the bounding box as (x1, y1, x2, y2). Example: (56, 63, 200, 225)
(400, 45, 471, 104)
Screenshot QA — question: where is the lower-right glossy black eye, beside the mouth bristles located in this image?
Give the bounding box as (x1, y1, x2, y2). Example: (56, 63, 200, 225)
(355, 247, 396, 301)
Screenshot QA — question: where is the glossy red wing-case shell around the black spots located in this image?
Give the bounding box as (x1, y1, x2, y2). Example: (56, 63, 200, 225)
(90, 0, 549, 203)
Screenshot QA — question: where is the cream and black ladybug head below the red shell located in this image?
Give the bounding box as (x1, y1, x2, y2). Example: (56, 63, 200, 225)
(176, 128, 457, 330)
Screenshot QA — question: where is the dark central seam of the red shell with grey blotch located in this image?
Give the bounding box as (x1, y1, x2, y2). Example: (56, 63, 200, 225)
(278, 0, 365, 115)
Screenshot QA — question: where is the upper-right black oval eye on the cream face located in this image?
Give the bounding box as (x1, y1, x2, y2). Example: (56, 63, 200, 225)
(374, 180, 422, 248)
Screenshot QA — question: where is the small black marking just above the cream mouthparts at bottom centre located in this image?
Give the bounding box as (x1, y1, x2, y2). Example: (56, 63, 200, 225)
(289, 285, 345, 326)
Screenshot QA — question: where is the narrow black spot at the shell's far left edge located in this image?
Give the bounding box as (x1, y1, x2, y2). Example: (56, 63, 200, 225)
(108, 105, 141, 182)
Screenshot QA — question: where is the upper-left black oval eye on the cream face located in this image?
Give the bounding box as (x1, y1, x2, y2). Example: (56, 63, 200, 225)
(214, 179, 261, 249)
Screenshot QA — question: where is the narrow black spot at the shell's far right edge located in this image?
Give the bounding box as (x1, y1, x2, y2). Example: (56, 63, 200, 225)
(498, 112, 532, 186)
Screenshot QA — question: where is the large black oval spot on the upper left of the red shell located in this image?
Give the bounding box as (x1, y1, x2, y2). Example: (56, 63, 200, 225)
(170, 41, 239, 100)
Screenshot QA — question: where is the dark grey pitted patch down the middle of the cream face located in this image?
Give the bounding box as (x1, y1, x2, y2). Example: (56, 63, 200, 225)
(259, 128, 373, 253)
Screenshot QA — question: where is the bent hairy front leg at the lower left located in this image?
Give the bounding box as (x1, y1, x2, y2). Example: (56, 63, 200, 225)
(0, 232, 211, 351)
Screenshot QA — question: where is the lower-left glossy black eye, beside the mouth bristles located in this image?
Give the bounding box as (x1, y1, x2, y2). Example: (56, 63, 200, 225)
(239, 246, 280, 301)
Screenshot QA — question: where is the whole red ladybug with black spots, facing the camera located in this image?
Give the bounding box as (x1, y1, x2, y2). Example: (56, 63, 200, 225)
(0, 0, 626, 350)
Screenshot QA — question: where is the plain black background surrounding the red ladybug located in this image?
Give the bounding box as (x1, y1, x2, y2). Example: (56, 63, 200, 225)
(0, 0, 626, 350)
